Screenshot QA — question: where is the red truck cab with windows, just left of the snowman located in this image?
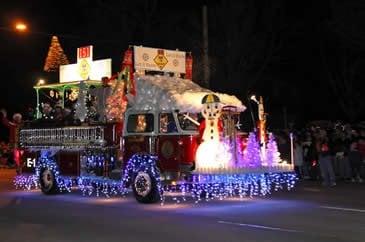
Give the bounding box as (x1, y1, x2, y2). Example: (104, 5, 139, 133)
(121, 109, 199, 181)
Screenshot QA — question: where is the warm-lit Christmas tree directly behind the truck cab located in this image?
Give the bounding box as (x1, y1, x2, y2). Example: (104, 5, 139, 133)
(106, 73, 127, 122)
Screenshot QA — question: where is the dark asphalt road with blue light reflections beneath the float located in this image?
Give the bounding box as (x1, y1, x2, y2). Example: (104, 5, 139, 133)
(0, 169, 365, 242)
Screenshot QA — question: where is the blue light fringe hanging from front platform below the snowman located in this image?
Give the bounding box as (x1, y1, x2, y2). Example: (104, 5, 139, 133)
(164, 173, 297, 203)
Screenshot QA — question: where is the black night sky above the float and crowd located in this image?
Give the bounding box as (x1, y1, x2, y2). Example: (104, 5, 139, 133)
(0, 0, 365, 130)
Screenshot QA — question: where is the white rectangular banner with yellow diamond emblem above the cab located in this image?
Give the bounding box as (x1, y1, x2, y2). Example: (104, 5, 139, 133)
(134, 46, 186, 73)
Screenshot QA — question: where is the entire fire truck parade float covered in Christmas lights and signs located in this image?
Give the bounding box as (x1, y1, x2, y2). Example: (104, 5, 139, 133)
(14, 46, 296, 203)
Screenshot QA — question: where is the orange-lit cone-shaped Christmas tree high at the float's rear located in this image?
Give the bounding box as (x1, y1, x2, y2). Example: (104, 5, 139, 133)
(43, 36, 69, 72)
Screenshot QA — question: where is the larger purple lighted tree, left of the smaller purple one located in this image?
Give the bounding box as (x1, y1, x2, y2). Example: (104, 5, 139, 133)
(243, 132, 261, 167)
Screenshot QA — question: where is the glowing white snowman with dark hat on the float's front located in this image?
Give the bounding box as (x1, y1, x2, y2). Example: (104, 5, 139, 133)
(196, 94, 231, 173)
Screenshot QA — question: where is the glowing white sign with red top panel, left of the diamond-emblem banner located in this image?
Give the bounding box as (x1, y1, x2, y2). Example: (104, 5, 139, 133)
(60, 45, 112, 83)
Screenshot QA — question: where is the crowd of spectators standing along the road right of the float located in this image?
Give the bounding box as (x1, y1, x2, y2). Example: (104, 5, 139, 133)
(276, 122, 365, 186)
